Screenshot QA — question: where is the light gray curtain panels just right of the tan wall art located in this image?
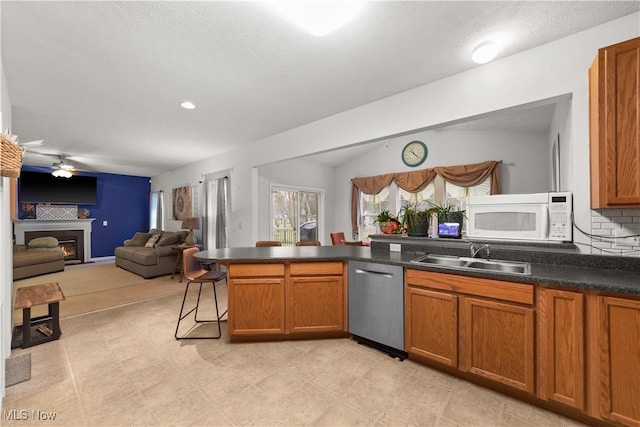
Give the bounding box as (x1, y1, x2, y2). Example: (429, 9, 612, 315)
(202, 177, 229, 249)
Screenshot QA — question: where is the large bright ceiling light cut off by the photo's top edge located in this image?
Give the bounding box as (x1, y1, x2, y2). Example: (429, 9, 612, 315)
(270, 0, 364, 37)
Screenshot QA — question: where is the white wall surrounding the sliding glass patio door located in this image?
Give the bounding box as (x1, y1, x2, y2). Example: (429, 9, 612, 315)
(257, 159, 335, 245)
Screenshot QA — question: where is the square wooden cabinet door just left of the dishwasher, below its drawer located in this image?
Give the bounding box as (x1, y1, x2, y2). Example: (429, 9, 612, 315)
(287, 276, 345, 333)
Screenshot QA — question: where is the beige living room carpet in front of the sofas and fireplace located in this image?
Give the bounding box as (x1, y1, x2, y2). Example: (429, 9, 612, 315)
(13, 260, 185, 324)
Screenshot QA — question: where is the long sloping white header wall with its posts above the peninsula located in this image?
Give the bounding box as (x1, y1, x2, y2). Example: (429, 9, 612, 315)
(152, 13, 640, 251)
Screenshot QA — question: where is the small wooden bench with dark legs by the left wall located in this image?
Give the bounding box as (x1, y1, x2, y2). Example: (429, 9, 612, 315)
(11, 282, 65, 348)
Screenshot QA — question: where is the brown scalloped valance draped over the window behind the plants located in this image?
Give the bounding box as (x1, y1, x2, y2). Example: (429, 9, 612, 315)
(351, 160, 502, 236)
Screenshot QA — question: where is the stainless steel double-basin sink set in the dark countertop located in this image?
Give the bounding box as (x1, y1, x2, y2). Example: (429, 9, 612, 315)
(411, 254, 531, 275)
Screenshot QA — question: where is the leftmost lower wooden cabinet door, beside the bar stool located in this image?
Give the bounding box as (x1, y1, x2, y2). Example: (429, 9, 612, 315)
(229, 277, 285, 336)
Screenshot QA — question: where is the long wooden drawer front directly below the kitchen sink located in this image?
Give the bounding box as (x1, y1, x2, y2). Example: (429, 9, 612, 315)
(405, 268, 533, 305)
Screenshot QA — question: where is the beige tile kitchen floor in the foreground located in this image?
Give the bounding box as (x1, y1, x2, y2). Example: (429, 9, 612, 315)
(0, 288, 581, 426)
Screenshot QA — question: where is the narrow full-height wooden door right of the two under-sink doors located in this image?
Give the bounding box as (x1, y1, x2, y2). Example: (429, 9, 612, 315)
(538, 289, 585, 410)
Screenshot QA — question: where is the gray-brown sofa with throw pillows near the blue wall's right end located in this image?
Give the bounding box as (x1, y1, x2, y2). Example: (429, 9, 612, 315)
(114, 230, 188, 279)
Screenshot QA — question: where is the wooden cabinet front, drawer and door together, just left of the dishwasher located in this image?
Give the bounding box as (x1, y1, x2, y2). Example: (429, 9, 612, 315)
(287, 262, 346, 333)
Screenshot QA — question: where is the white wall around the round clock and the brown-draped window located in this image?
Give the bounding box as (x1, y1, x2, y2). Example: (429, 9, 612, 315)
(334, 129, 551, 237)
